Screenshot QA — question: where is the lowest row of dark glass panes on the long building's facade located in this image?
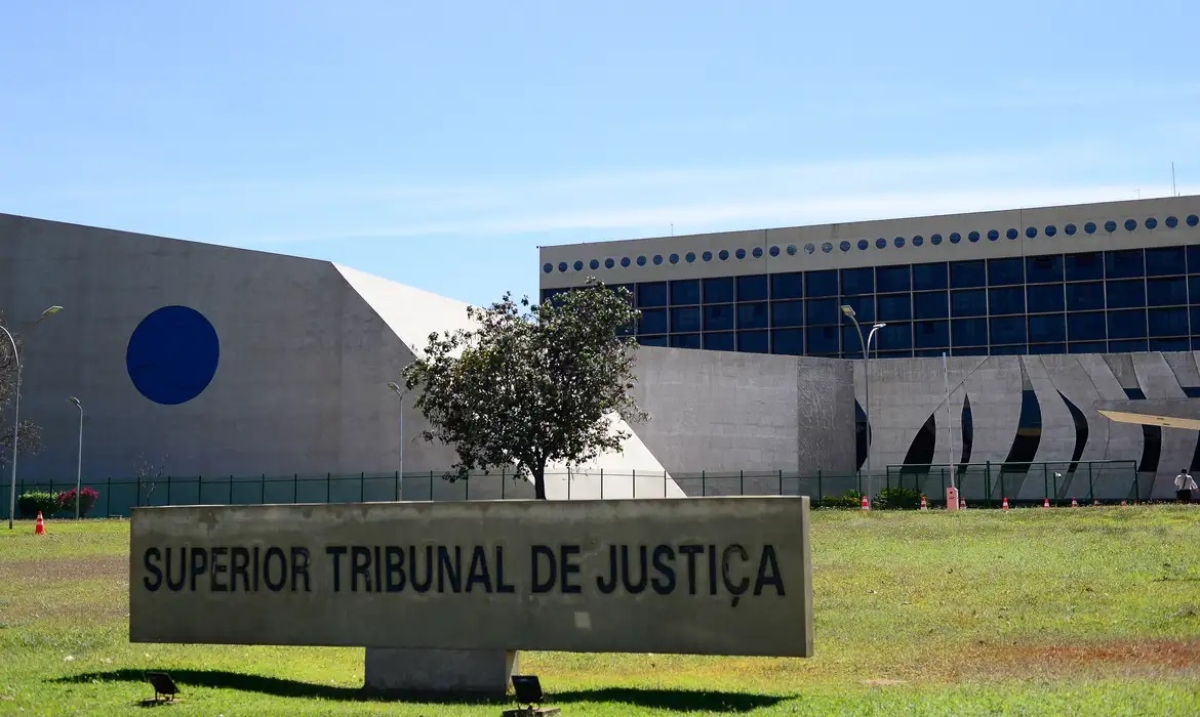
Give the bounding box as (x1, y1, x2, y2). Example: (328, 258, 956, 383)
(638, 329, 1200, 359)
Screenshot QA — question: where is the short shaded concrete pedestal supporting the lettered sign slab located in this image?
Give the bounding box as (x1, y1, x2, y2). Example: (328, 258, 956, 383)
(364, 647, 518, 697)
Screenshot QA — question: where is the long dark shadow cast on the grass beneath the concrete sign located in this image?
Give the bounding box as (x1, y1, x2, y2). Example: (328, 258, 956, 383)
(50, 669, 787, 713)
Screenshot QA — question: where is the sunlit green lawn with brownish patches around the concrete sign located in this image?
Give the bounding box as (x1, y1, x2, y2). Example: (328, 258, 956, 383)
(0, 506, 1200, 717)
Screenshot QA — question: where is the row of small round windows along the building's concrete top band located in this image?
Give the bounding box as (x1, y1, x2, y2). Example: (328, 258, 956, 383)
(541, 215, 1200, 273)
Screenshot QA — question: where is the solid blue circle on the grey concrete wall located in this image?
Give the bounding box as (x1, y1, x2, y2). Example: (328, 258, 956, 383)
(125, 306, 221, 405)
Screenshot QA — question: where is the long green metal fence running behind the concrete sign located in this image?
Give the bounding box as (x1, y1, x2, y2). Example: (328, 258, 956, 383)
(0, 462, 1151, 518)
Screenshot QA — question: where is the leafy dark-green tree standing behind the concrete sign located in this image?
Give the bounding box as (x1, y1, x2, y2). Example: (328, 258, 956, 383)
(402, 279, 648, 500)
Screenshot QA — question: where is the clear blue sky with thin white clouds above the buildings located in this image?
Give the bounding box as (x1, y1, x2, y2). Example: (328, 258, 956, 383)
(0, 0, 1200, 302)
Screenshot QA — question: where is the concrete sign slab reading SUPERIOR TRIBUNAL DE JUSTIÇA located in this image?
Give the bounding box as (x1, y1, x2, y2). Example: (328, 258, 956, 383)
(130, 498, 812, 657)
